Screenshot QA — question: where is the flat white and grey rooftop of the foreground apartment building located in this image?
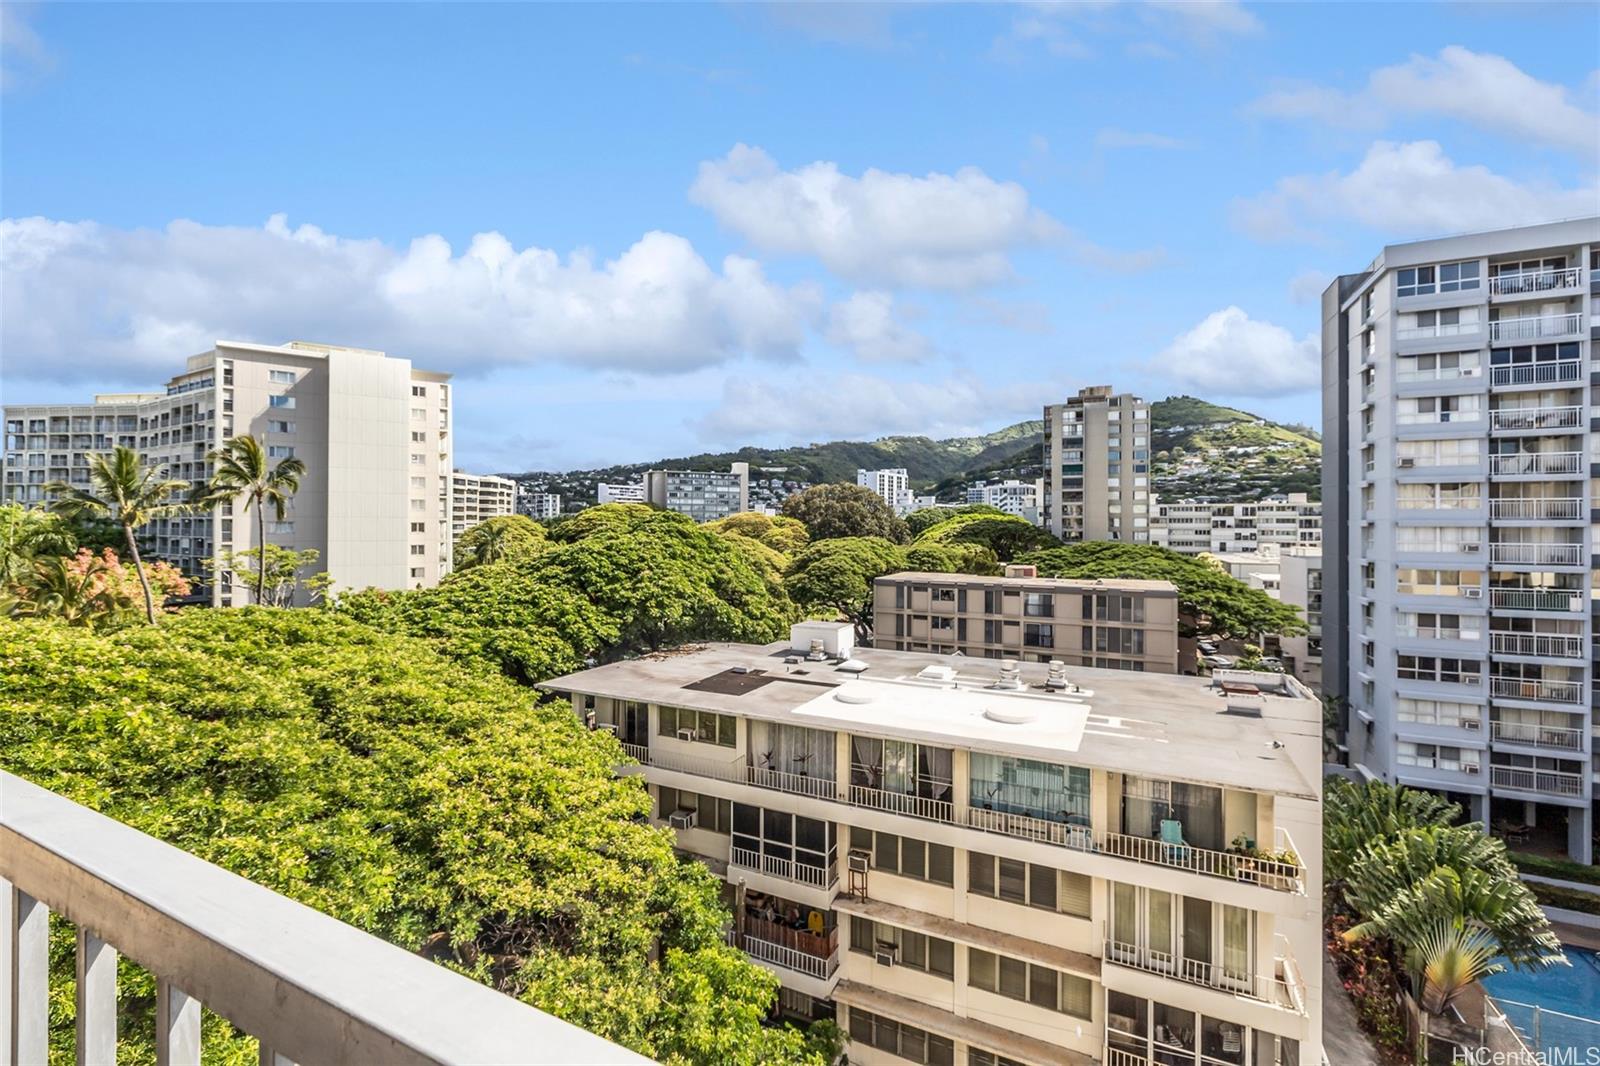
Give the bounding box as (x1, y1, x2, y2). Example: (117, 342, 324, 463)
(542, 642, 1322, 800)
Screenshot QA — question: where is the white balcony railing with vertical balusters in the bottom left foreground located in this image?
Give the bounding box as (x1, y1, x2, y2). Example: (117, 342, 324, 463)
(0, 773, 650, 1066)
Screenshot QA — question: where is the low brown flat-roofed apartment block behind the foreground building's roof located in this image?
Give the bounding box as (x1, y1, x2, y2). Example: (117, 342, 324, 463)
(872, 567, 1194, 674)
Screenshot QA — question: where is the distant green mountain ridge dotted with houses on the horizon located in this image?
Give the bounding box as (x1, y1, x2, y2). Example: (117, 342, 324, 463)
(506, 395, 1322, 501)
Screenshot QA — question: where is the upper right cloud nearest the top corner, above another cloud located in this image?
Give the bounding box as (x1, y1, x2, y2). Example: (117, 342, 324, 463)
(1248, 45, 1600, 160)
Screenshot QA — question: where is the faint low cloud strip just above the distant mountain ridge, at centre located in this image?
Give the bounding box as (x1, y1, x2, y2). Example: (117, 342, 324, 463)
(693, 373, 1067, 443)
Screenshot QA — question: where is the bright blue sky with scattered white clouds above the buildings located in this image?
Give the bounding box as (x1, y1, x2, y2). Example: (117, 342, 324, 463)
(0, 3, 1600, 471)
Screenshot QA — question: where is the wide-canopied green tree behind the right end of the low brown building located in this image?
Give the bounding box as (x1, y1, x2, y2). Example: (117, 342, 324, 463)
(1016, 541, 1306, 639)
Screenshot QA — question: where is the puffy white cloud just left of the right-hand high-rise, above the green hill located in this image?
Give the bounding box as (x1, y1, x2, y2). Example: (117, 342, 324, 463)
(1149, 307, 1322, 395)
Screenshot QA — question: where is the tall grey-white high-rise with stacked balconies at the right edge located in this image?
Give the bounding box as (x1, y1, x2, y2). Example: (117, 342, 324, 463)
(1322, 218, 1600, 863)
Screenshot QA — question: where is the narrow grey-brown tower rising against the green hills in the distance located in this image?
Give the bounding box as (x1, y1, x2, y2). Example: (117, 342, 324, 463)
(1045, 386, 1150, 544)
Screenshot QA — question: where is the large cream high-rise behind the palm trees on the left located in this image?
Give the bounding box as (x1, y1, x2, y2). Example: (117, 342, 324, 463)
(5, 341, 451, 605)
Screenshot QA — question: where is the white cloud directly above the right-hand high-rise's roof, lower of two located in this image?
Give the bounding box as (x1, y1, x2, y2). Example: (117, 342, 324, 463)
(1232, 141, 1600, 240)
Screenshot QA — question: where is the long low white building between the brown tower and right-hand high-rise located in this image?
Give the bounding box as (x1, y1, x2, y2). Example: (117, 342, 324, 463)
(1150, 493, 1322, 555)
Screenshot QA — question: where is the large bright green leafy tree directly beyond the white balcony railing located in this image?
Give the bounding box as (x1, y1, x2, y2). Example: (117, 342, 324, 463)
(0, 605, 829, 1066)
